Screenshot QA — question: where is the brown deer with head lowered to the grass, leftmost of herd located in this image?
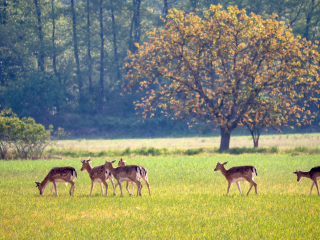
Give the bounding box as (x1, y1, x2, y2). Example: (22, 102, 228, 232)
(36, 167, 77, 196)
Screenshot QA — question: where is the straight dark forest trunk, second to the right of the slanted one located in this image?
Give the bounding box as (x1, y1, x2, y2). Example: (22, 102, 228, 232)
(99, 0, 104, 111)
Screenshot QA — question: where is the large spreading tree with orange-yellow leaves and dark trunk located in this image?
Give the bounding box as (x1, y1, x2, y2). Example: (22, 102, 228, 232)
(124, 5, 320, 151)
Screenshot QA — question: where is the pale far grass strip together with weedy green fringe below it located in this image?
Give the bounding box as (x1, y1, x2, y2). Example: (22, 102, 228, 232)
(44, 133, 320, 158)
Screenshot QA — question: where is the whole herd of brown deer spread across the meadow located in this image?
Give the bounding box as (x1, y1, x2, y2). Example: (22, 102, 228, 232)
(36, 158, 320, 196)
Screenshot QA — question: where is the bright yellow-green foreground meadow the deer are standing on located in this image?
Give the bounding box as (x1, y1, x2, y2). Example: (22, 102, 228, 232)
(0, 154, 320, 239)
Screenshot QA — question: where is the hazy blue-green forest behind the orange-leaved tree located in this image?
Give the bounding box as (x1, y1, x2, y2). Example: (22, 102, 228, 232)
(0, 0, 320, 137)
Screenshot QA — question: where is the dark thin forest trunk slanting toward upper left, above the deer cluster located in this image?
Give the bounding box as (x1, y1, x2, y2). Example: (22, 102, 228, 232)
(71, 0, 84, 108)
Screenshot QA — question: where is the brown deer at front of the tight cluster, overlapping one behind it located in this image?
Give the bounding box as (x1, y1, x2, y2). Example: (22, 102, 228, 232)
(105, 161, 142, 196)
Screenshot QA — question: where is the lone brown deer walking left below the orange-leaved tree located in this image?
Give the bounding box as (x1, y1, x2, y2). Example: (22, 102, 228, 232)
(214, 162, 258, 195)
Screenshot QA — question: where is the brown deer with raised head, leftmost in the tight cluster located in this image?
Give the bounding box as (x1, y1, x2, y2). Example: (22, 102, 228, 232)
(81, 159, 115, 195)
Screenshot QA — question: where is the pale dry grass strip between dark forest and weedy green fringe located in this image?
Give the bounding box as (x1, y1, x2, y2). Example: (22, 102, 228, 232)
(55, 133, 320, 151)
